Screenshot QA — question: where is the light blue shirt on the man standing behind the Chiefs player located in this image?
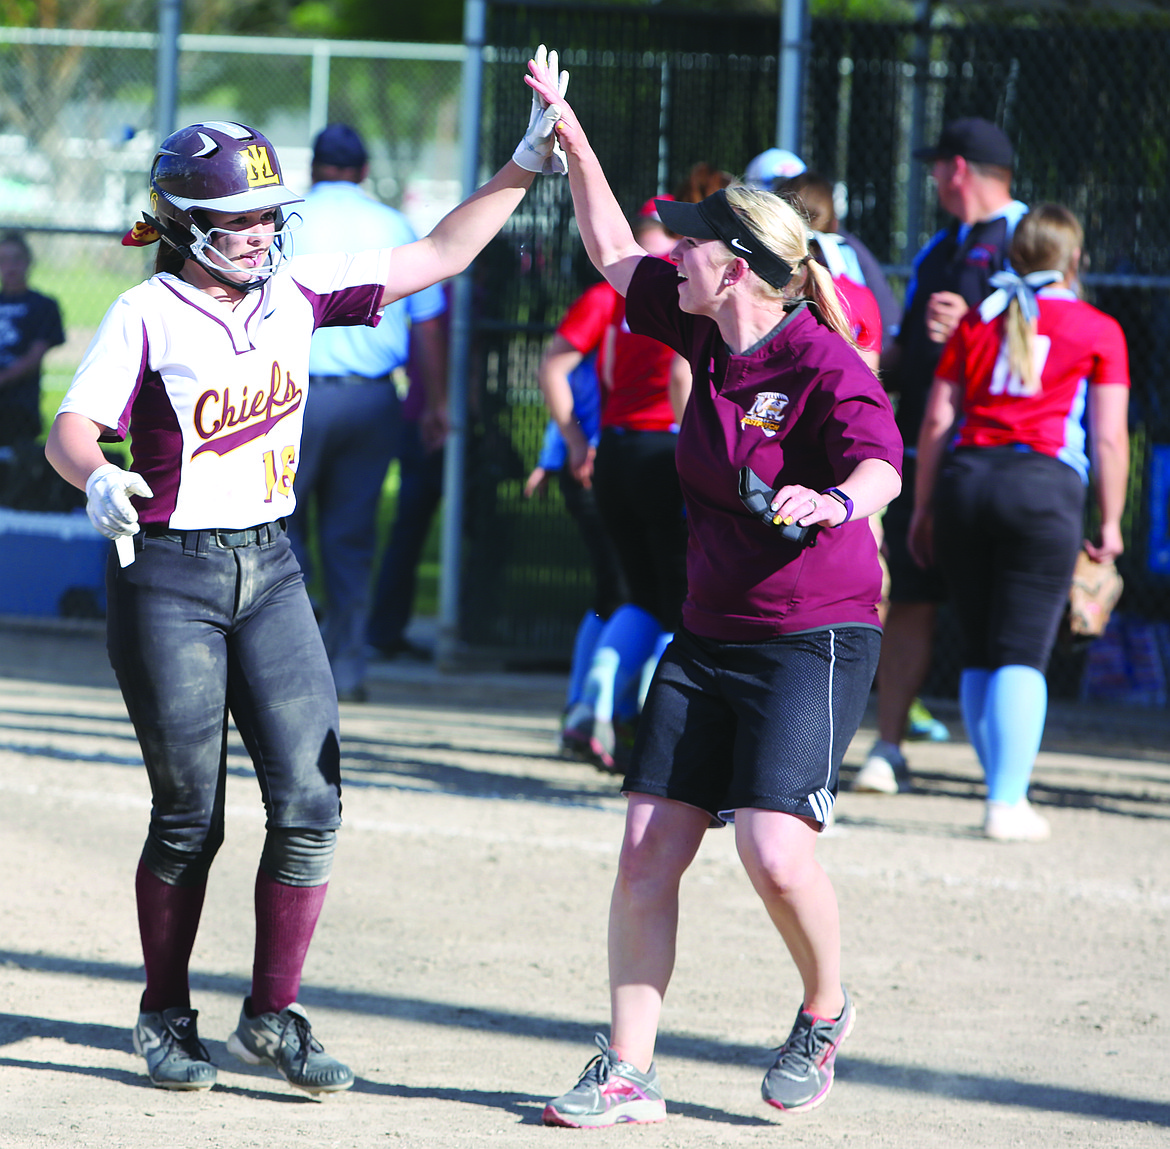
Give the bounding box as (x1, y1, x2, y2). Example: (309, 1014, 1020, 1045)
(293, 180, 447, 379)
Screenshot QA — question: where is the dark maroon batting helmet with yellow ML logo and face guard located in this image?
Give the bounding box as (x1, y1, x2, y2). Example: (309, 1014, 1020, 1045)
(145, 121, 301, 291)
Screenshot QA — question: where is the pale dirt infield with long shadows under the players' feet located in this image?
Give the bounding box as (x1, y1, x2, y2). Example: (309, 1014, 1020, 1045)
(0, 626, 1170, 1149)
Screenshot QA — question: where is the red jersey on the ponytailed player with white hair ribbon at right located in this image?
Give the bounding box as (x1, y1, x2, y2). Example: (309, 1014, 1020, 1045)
(935, 288, 1129, 481)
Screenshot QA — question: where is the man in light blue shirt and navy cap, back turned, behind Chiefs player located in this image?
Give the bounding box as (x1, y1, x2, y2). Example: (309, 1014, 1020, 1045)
(289, 123, 447, 702)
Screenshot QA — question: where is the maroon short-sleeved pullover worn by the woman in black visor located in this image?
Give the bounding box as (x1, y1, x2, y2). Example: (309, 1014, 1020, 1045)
(626, 257, 902, 642)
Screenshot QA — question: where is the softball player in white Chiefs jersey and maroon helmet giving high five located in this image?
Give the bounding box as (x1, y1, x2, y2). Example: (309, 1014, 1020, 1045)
(46, 53, 567, 1093)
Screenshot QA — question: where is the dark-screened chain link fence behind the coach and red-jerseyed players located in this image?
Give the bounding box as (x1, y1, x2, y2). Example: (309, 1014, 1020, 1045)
(464, 4, 1170, 720)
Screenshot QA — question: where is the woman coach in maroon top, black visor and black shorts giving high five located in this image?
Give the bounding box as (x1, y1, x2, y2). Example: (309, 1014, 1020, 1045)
(529, 62, 901, 1127)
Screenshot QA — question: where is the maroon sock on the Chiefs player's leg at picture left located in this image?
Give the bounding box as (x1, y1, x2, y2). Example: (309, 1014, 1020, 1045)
(135, 861, 207, 1012)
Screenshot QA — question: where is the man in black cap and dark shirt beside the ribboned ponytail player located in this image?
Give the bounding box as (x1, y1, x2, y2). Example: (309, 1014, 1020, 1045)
(853, 117, 1027, 793)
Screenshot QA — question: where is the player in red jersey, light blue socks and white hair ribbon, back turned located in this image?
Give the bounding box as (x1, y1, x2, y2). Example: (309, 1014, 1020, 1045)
(910, 204, 1129, 840)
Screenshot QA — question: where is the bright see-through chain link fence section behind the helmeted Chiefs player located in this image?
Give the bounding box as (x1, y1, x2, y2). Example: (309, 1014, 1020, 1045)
(0, 28, 463, 413)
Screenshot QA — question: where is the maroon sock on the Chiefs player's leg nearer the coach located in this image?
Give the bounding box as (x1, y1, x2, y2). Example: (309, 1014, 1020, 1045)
(248, 871, 329, 1016)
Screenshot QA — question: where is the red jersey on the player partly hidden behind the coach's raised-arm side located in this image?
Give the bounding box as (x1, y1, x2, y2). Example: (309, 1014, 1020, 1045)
(557, 280, 674, 431)
